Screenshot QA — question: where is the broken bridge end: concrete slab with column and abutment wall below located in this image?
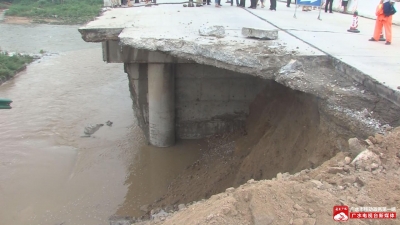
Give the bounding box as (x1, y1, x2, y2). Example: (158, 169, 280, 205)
(79, 5, 397, 147)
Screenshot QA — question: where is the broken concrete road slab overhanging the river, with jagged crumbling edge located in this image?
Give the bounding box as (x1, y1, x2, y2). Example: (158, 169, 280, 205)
(79, 5, 397, 139)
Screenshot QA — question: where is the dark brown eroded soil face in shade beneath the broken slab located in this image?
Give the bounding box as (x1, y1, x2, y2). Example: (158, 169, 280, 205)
(138, 82, 355, 214)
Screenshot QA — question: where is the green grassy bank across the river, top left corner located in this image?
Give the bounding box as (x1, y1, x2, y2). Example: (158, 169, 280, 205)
(2, 0, 103, 24)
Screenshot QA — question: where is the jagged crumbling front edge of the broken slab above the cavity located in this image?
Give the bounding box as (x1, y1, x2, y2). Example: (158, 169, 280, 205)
(120, 39, 390, 136)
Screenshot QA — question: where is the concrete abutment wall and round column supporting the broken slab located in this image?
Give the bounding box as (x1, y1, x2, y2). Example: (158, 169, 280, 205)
(95, 40, 272, 147)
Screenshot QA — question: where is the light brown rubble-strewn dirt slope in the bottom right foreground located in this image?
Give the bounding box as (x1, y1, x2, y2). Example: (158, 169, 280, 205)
(137, 128, 400, 225)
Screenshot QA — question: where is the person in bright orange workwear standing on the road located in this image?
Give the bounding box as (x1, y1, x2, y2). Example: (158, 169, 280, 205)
(369, 0, 392, 45)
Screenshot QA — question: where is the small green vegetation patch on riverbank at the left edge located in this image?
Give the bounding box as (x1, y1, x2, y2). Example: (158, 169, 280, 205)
(0, 52, 33, 80)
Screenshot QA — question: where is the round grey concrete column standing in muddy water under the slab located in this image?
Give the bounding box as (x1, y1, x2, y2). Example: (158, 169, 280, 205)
(148, 64, 175, 147)
